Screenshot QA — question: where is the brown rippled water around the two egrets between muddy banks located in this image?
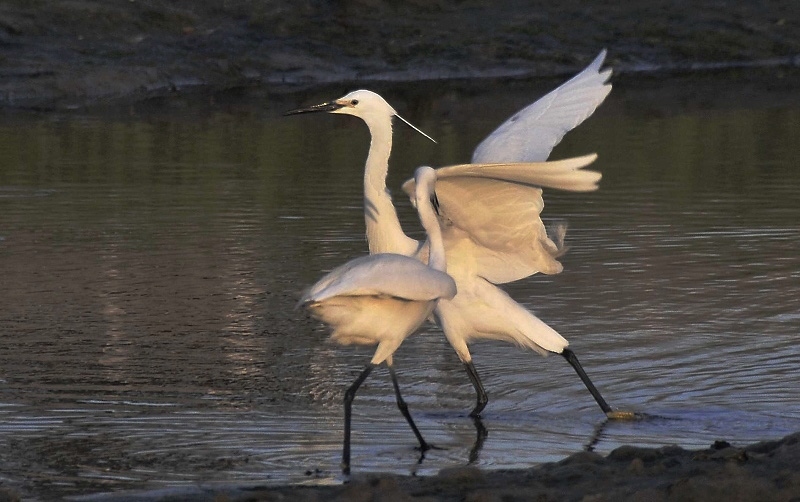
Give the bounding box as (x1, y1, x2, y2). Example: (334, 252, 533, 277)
(0, 76, 800, 498)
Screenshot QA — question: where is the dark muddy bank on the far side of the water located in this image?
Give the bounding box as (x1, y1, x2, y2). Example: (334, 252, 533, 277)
(0, 0, 800, 109)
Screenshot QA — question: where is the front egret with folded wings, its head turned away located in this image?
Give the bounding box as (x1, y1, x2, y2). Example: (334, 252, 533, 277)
(298, 167, 456, 474)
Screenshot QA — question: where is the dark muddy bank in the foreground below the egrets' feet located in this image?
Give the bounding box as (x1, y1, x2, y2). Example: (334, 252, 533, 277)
(67, 433, 800, 502)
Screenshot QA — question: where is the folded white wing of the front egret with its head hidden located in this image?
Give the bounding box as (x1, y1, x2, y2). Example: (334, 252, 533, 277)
(298, 253, 456, 305)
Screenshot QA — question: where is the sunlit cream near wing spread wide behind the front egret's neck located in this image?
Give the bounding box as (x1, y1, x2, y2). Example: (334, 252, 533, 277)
(403, 154, 601, 284)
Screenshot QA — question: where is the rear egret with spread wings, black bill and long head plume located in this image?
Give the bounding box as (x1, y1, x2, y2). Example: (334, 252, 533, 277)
(286, 51, 632, 418)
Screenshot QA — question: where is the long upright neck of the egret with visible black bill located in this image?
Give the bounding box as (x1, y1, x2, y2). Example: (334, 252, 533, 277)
(364, 117, 417, 256)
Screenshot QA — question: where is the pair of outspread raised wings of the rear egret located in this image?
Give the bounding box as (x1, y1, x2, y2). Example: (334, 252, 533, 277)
(396, 50, 611, 284)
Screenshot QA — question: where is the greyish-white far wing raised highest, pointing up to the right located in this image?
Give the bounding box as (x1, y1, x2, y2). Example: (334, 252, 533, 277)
(472, 50, 611, 163)
